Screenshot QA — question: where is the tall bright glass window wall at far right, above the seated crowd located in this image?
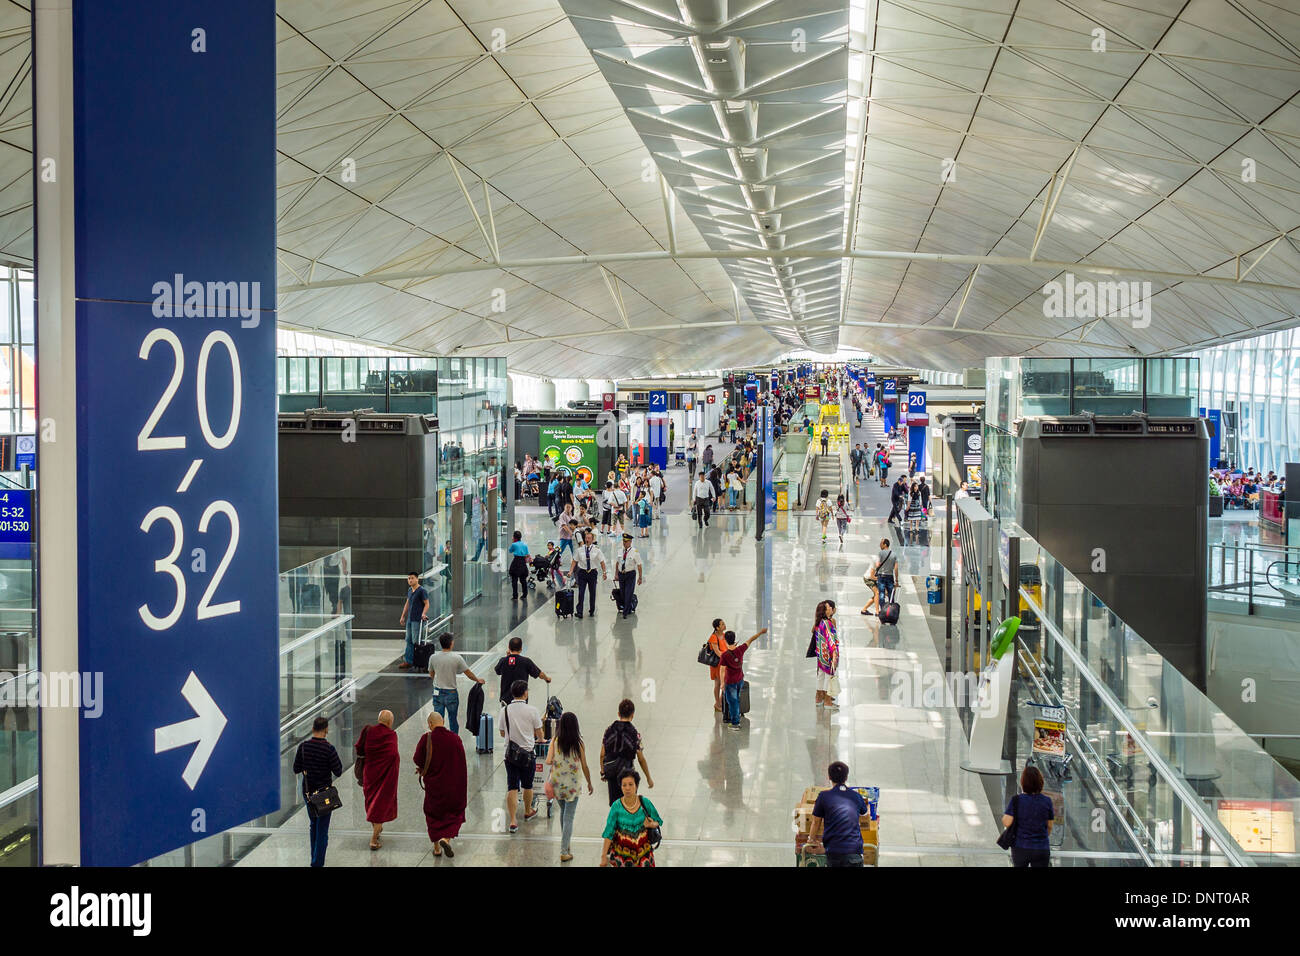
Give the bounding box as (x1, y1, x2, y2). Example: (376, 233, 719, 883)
(1192, 329, 1300, 472)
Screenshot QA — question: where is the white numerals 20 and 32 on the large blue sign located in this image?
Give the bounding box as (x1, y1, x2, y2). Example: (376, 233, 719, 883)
(135, 329, 243, 631)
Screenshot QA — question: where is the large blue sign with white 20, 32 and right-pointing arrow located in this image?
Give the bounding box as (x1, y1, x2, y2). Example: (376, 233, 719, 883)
(69, 0, 280, 866)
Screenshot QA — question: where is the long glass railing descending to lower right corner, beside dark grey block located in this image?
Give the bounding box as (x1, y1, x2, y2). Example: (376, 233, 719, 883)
(1015, 529, 1300, 865)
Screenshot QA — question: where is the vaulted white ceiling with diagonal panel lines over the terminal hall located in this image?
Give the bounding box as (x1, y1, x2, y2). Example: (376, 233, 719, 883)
(12, 0, 1300, 378)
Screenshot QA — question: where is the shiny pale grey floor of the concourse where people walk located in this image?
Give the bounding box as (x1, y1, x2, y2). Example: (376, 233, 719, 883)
(243, 411, 1008, 866)
